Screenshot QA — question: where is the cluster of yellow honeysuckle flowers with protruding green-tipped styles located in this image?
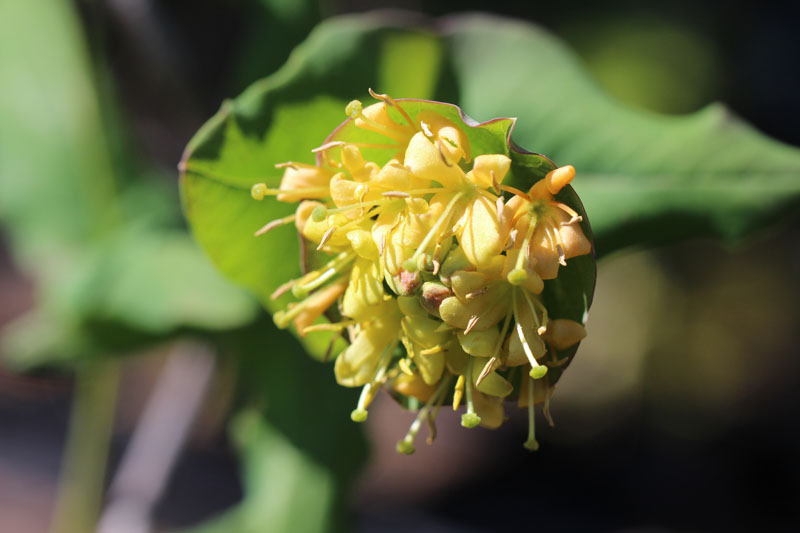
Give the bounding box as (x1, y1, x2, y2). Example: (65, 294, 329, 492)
(251, 90, 592, 453)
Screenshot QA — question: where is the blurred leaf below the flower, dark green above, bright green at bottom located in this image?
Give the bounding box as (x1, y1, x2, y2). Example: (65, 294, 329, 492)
(191, 316, 367, 533)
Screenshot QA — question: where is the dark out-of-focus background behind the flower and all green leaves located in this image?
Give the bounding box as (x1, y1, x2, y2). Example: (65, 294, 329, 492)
(0, 0, 800, 532)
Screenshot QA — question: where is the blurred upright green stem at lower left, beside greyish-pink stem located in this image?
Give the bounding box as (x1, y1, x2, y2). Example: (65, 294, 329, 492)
(50, 359, 120, 533)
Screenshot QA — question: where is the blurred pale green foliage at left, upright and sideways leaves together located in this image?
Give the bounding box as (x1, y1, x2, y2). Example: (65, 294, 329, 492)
(0, 0, 257, 368)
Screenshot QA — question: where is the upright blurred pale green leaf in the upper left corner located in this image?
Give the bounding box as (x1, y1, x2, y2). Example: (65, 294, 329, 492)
(0, 1, 118, 258)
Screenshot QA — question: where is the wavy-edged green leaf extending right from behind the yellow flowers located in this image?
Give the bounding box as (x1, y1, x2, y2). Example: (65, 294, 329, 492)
(443, 16, 800, 255)
